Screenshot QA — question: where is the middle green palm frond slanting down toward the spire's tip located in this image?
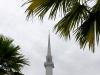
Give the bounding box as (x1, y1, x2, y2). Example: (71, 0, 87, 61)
(55, 3, 88, 38)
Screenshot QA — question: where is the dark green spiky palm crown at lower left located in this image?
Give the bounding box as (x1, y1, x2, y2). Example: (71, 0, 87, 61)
(0, 35, 28, 75)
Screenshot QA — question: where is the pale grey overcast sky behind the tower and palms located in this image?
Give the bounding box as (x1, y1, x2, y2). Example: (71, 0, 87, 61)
(0, 0, 100, 75)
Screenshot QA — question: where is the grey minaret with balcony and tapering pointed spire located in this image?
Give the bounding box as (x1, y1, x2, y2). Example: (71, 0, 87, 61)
(44, 34, 54, 75)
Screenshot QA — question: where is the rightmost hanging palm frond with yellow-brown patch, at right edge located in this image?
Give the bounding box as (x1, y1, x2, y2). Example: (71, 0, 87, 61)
(76, 0, 100, 52)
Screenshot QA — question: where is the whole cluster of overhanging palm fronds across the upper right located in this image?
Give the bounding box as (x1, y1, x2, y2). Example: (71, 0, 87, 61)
(25, 0, 100, 52)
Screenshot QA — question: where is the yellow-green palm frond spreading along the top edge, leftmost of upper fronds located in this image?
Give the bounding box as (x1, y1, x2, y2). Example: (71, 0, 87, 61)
(26, 0, 87, 19)
